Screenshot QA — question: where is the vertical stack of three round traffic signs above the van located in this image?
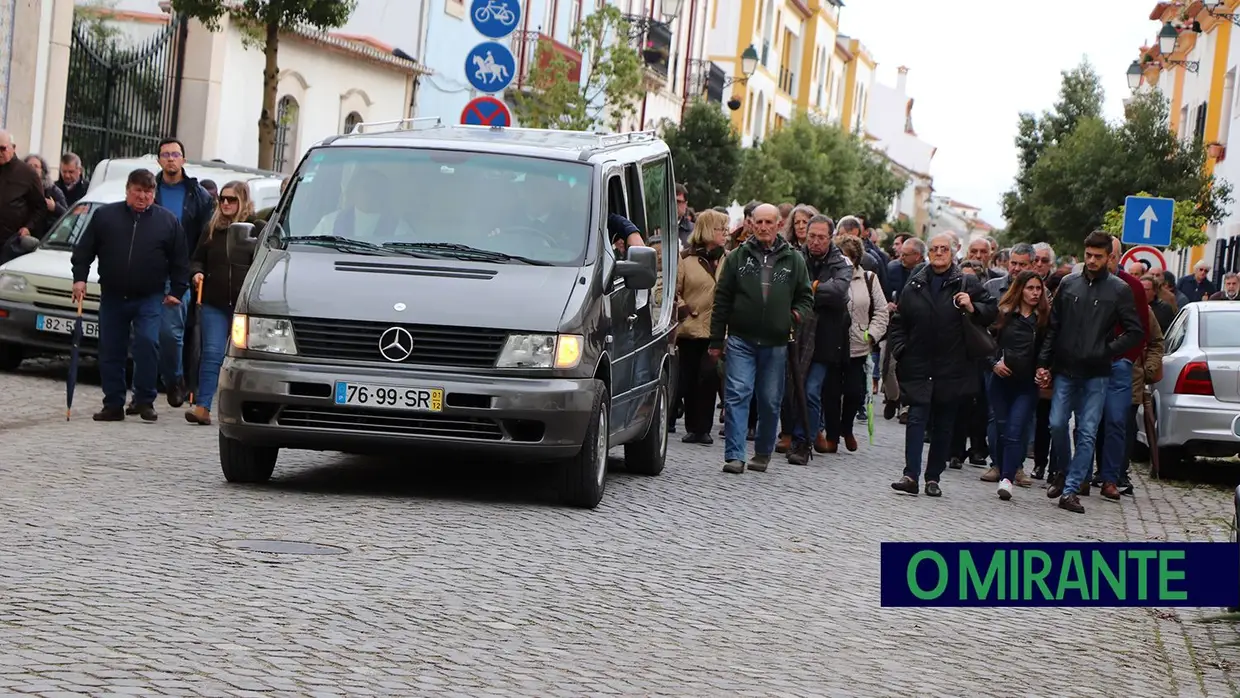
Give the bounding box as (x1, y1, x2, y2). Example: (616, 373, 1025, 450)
(461, 0, 522, 126)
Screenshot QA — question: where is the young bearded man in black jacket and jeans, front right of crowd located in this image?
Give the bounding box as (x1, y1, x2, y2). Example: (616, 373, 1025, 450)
(1038, 231, 1145, 513)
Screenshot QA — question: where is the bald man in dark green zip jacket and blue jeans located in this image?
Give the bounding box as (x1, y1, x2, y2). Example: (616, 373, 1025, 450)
(711, 203, 813, 474)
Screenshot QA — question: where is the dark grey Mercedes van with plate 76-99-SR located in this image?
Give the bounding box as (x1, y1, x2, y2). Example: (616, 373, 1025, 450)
(217, 119, 680, 508)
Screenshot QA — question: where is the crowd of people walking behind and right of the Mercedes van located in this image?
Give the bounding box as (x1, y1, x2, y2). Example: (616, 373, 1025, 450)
(672, 190, 1240, 513)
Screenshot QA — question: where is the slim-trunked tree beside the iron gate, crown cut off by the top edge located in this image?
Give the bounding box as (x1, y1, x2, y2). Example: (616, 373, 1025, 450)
(172, 0, 357, 170)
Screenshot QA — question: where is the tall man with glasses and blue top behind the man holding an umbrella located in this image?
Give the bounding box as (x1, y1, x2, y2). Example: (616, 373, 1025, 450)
(155, 138, 216, 407)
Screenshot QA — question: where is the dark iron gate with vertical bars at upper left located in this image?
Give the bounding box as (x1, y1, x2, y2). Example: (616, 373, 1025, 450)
(62, 16, 188, 172)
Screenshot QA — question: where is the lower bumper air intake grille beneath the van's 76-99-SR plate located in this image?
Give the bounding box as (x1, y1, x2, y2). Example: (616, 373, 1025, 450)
(277, 405, 503, 441)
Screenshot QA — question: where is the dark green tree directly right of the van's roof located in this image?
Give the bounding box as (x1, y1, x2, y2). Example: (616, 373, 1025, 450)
(663, 99, 742, 211)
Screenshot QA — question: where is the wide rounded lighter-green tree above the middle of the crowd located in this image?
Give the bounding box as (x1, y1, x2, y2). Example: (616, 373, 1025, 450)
(733, 115, 905, 226)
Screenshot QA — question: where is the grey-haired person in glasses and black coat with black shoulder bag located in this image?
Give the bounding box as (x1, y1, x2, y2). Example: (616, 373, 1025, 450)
(888, 233, 998, 497)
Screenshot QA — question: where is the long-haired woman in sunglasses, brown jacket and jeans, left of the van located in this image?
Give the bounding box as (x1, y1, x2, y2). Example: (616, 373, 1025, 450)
(185, 181, 254, 424)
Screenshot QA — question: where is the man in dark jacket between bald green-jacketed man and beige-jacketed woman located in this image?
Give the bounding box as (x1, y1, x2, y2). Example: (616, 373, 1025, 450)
(787, 213, 852, 465)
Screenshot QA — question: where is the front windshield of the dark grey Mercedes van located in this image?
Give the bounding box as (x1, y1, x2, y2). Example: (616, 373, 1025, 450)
(280, 148, 591, 265)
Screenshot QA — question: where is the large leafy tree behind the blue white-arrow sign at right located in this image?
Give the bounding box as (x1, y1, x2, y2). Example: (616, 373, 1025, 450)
(1003, 63, 1231, 253)
